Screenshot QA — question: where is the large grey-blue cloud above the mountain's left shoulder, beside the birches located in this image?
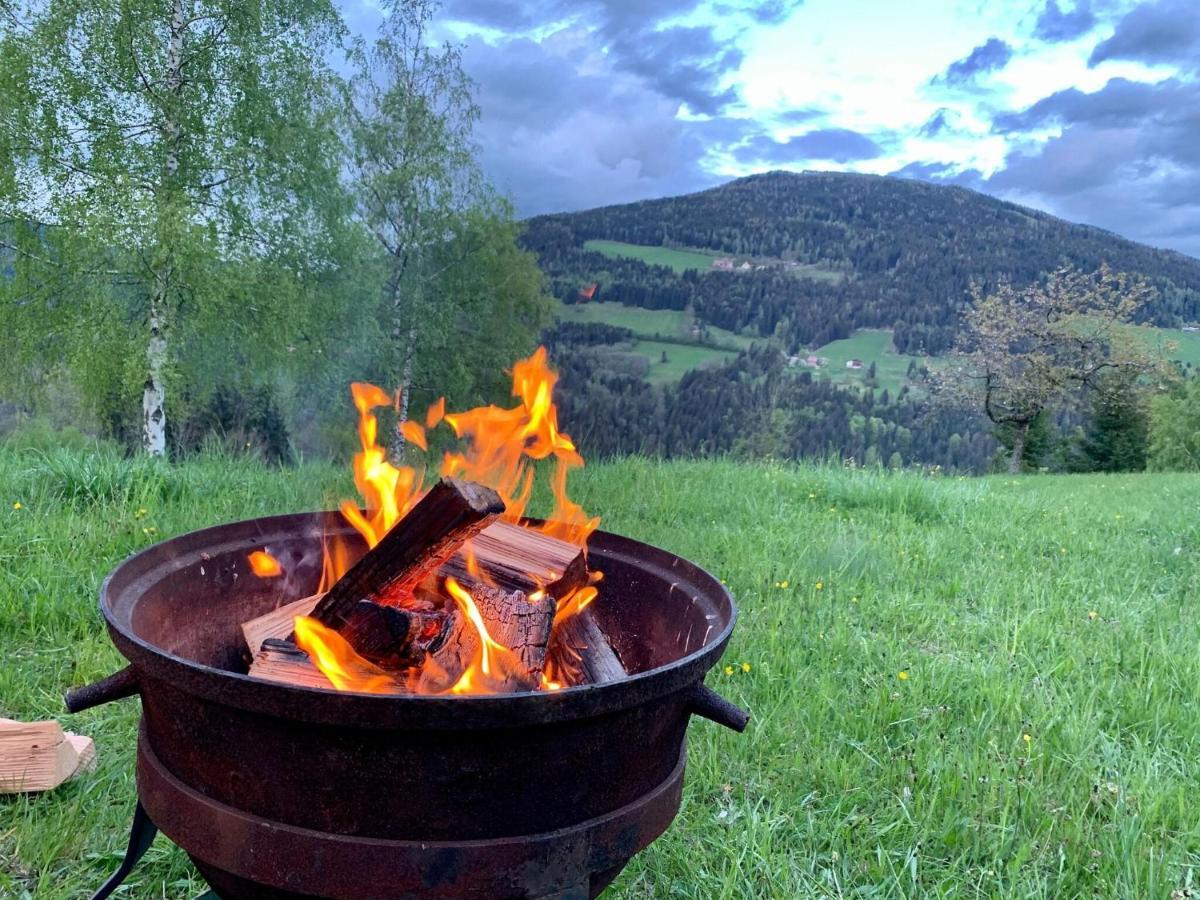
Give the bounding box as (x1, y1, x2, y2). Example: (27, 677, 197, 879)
(463, 29, 734, 215)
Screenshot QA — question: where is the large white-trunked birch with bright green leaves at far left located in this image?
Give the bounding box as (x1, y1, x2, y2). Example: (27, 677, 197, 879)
(0, 0, 341, 456)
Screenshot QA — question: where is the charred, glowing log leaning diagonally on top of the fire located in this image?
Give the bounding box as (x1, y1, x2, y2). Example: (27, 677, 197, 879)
(312, 478, 504, 633)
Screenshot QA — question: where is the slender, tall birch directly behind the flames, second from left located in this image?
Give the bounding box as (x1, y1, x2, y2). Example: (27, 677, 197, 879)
(347, 0, 484, 454)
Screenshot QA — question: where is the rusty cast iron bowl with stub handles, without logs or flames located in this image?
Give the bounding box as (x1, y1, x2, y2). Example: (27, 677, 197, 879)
(68, 514, 746, 899)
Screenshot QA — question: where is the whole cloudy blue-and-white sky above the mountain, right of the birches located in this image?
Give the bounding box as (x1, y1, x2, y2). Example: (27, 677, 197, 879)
(342, 0, 1200, 257)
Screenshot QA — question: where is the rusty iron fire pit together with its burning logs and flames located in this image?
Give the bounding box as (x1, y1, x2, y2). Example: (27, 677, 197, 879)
(67, 352, 748, 900)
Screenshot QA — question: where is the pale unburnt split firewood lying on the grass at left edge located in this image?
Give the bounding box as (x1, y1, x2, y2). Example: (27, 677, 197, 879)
(0, 719, 96, 793)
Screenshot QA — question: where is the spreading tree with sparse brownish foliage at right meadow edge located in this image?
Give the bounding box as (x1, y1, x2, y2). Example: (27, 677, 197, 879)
(938, 266, 1160, 473)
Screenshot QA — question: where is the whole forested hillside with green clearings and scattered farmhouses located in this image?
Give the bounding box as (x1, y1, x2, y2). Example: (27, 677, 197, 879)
(523, 172, 1200, 472)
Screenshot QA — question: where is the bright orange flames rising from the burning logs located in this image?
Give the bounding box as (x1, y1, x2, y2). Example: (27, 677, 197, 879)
(251, 347, 600, 694)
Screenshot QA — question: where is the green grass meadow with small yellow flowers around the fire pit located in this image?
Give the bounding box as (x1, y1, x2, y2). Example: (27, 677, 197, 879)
(0, 448, 1200, 900)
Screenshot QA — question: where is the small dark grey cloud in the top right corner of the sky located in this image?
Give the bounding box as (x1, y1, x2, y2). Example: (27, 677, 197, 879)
(1088, 0, 1200, 71)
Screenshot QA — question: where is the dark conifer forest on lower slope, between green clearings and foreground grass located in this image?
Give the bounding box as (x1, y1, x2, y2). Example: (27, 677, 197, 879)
(545, 324, 996, 472)
